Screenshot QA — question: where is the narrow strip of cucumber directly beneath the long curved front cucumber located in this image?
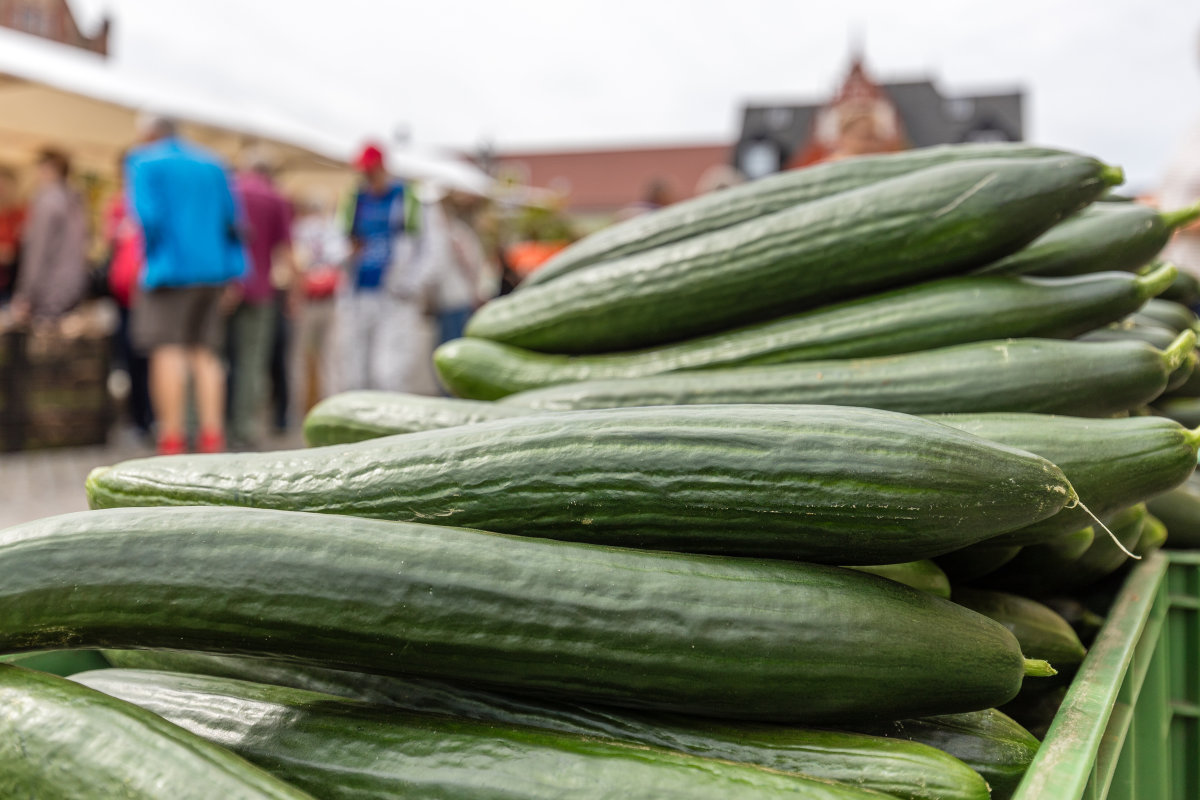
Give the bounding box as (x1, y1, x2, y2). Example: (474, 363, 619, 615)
(87, 650, 988, 800)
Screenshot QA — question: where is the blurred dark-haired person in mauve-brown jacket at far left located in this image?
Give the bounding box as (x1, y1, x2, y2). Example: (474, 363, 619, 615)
(12, 148, 88, 324)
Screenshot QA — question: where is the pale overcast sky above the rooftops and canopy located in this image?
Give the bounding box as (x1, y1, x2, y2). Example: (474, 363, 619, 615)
(70, 0, 1200, 190)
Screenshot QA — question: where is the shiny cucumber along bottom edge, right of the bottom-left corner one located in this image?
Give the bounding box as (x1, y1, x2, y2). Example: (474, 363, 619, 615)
(77, 669, 902, 800)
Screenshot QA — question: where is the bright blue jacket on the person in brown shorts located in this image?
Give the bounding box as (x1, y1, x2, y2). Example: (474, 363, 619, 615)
(125, 137, 246, 289)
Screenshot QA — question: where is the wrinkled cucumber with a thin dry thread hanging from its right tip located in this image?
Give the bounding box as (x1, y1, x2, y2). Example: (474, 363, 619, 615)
(88, 405, 1074, 564)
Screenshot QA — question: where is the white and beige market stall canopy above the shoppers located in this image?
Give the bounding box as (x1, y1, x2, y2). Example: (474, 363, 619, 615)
(0, 28, 491, 194)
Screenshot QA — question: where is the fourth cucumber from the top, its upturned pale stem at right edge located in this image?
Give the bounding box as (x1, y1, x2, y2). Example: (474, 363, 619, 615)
(502, 331, 1195, 416)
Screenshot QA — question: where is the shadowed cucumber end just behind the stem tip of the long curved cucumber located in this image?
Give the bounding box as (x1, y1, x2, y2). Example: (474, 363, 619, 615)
(953, 587, 1087, 672)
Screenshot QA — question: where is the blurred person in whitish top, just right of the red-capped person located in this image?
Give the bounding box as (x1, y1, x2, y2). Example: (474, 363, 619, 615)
(426, 192, 499, 344)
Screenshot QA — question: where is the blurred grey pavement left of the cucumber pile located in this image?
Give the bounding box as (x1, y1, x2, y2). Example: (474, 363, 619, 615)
(0, 431, 302, 528)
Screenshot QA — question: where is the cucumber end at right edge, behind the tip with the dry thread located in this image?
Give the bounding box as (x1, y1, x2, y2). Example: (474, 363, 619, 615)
(930, 414, 1200, 546)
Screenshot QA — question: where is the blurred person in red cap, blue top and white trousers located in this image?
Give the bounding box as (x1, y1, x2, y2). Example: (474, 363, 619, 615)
(331, 144, 438, 395)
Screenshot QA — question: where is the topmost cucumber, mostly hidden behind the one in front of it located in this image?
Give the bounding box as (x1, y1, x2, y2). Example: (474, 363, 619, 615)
(528, 143, 1070, 291)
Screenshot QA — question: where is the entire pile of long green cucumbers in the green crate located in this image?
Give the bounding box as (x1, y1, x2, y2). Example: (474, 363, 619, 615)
(0, 145, 1200, 800)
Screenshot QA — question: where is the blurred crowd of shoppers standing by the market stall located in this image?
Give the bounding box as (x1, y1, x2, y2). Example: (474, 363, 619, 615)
(0, 123, 499, 455)
